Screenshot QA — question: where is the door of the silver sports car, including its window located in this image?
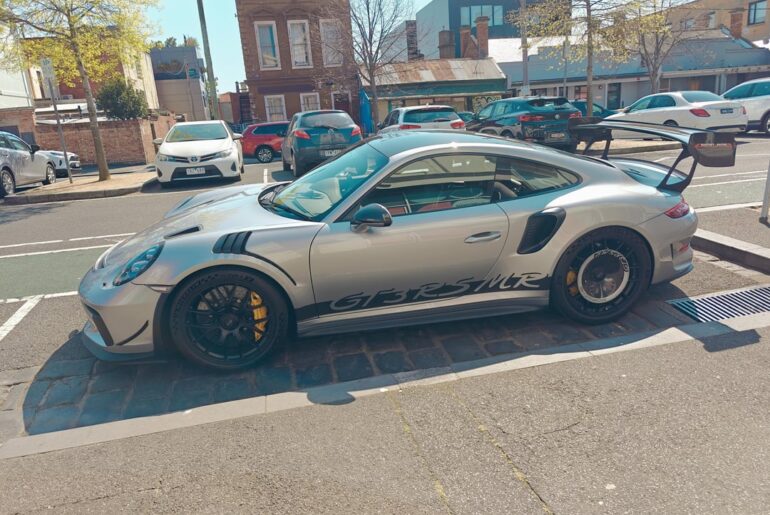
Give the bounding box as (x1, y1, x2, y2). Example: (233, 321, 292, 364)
(310, 153, 508, 316)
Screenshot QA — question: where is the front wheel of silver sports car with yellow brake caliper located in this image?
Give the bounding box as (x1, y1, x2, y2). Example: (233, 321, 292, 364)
(169, 269, 289, 370)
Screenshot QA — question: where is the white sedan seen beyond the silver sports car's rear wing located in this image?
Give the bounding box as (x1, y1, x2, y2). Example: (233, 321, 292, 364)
(606, 91, 748, 136)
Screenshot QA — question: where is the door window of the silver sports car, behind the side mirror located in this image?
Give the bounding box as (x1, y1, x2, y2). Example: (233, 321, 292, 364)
(361, 154, 499, 216)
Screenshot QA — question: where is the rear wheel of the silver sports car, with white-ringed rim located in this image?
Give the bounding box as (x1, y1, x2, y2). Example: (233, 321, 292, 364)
(551, 227, 652, 325)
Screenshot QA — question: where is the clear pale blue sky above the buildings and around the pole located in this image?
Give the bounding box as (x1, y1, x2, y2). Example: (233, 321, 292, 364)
(147, 0, 430, 93)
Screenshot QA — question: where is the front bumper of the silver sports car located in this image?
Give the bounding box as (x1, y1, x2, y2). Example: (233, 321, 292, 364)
(78, 268, 162, 360)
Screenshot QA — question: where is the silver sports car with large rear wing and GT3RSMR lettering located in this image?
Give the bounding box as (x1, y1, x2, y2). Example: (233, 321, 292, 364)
(80, 120, 735, 369)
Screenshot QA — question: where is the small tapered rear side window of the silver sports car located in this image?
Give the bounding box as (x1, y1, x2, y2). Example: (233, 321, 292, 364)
(492, 158, 580, 202)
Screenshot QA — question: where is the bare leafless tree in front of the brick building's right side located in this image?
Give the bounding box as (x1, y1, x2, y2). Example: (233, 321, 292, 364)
(321, 0, 412, 125)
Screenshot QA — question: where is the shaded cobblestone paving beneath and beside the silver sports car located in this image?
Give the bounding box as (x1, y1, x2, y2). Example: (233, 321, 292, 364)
(6, 300, 690, 434)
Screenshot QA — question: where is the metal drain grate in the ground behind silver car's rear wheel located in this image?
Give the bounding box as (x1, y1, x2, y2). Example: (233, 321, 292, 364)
(668, 286, 770, 322)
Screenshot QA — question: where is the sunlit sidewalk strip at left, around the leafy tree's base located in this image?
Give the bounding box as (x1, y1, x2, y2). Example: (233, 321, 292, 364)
(5, 171, 156, 205)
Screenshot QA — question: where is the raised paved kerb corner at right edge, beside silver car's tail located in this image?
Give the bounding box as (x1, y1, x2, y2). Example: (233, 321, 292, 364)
(692, 206, 770, 273)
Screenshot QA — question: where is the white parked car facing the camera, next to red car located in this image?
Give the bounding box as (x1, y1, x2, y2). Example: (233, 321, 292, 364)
(153, 121, 244, 187)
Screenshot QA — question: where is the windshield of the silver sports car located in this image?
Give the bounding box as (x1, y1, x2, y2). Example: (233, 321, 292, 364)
(268, 142, 388, 221)
